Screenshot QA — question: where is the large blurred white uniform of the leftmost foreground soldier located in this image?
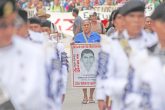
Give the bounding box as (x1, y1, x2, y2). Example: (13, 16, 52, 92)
(0, 38, 51, 110)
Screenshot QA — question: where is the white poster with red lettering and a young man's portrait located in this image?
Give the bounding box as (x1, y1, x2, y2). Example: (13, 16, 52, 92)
(71, 44, 100, 88)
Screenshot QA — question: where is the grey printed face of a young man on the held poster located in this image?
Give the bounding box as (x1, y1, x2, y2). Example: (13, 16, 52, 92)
(81, 49, 95, 71)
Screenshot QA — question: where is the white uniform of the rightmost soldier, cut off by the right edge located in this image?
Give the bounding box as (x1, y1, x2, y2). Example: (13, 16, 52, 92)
(123, 51, 165, 110)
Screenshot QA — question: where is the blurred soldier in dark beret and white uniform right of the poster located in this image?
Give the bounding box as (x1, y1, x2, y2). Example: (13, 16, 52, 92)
(96, 1, 157, 110)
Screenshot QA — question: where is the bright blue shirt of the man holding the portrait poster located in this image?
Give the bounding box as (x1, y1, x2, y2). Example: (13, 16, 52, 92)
(74, 32, 101, 43)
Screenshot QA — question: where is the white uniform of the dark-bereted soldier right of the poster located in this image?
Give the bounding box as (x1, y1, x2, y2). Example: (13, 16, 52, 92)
(96, 31, 157, 110)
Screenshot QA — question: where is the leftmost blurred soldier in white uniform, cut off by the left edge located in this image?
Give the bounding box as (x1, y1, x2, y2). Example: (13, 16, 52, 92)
(0, 0, 60, 110)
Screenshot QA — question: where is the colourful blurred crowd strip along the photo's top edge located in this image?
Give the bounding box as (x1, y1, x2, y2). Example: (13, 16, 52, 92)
(17, 0, 163, 12)
